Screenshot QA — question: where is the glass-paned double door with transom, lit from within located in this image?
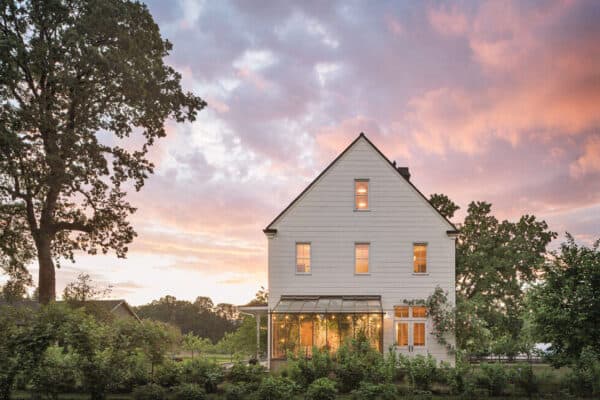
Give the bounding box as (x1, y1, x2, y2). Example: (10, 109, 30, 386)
(394, 306, 427, 355)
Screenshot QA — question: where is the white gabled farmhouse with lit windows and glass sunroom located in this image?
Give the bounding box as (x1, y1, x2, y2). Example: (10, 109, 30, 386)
(264, 133, 458, 365)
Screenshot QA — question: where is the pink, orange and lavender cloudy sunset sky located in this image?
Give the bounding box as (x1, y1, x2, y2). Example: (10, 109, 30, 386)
(22, 0, 600, 304)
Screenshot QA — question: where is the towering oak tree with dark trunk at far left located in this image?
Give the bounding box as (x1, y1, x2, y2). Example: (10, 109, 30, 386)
(0, 0, 205, 303)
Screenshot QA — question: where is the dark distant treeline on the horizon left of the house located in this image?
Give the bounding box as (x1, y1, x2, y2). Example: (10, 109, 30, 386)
(135, 296, 240, 343)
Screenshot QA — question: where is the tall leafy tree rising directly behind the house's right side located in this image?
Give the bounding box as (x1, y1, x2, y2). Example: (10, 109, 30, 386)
(456, 202, 556, 356)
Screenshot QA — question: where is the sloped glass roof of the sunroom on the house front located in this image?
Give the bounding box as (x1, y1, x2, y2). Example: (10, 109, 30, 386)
(272, 296, 383, 314)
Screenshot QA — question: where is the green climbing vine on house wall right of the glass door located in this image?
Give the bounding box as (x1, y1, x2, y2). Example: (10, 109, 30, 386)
(404, 286, 455, 353)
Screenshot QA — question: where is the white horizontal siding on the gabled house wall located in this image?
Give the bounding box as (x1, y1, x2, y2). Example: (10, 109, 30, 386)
(269, 139, 455, 359)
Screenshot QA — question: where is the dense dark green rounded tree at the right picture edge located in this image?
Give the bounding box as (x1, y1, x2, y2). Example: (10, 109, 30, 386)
(529, 234, 600, 366)
